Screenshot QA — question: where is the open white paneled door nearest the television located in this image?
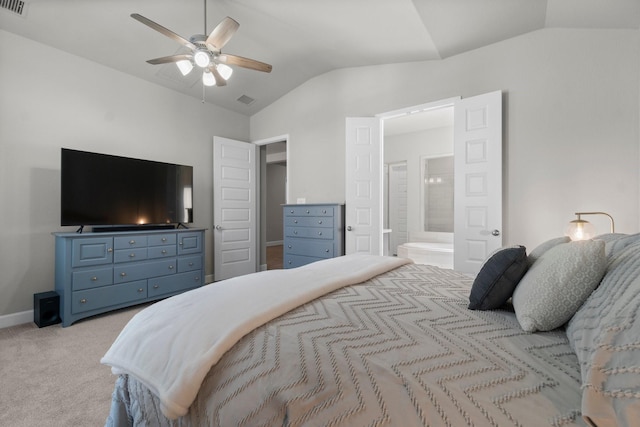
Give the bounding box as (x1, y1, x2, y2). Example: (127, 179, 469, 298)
(213, 136, 257, 281)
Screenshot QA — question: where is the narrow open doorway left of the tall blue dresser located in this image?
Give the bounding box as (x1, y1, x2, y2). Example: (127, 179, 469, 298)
(258, 138, 287, 270)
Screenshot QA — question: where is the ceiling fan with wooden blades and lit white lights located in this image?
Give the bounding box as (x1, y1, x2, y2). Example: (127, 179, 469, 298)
(131, 0, 272, 86)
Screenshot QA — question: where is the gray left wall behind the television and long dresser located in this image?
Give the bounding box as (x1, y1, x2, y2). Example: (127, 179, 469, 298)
(0, 30, 249, 316)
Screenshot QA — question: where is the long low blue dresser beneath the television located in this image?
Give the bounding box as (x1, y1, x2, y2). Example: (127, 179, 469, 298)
(54, 229, 204, 327)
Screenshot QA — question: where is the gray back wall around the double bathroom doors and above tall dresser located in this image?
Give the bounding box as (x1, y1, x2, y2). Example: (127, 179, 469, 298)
(251, 29, 640, 254)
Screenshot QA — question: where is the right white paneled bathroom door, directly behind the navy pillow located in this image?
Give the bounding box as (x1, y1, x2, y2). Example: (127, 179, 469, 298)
(454, 91, 502, 274)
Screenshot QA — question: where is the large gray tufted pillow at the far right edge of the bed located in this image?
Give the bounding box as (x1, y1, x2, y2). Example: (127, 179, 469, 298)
(567, 241, 640, 426)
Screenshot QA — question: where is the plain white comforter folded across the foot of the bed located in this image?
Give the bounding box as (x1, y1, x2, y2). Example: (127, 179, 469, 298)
(101, 254, 410, 419)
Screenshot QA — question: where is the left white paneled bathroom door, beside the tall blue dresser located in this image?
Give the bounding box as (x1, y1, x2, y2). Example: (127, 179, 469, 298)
(345, 117, 383, 255)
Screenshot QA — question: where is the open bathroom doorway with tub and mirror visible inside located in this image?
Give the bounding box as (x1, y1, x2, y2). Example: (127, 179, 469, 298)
(383, 105, 454, 268)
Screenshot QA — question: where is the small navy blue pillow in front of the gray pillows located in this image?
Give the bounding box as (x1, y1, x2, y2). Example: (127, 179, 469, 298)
(469, 246, 529, 310)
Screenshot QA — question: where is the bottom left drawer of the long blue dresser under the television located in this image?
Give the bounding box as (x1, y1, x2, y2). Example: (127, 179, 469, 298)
(71, 280, 147, 313)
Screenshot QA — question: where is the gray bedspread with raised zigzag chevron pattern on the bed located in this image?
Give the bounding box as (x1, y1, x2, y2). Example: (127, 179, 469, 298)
(107, 264, 584, 427)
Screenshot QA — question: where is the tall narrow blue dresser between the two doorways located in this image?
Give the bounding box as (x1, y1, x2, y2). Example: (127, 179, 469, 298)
(283, 204, 344, 268)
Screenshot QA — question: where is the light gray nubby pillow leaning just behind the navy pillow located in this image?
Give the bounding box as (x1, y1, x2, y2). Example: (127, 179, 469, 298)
(513, 240, 606, 332)
